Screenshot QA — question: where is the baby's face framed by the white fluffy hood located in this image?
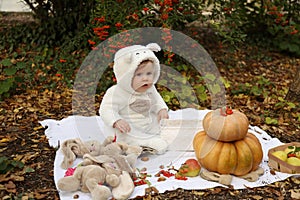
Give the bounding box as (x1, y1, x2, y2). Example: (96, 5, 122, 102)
(131, 62, 154, 92)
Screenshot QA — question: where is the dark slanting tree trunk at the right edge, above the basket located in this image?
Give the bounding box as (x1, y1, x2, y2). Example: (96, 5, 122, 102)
(286, 66, 300, 102)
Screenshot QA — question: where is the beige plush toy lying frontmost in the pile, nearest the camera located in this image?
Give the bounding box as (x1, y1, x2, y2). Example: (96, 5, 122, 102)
(57, 165, 134, 200)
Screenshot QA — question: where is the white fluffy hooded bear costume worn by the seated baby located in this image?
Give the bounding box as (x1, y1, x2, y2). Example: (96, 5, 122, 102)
(99, 43, 168, 154)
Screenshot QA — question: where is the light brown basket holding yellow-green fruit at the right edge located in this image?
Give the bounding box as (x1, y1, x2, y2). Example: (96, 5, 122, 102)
(268, 142, 300, 174)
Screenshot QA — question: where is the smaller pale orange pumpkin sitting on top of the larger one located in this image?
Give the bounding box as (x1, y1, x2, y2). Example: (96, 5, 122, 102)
(203, 107, 249, 142)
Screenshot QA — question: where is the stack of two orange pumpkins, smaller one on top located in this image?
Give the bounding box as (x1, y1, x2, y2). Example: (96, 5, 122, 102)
(193, 107, 263, 176)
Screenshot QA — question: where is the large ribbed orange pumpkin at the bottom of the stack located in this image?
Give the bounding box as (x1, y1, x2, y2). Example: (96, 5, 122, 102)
(193, 131, 263, 176)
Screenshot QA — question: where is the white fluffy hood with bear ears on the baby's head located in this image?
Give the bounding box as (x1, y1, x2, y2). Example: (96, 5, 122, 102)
(113, 43, 160, 93)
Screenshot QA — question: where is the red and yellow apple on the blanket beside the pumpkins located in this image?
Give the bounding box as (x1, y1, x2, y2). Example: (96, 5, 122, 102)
(177, 158, 201, 177)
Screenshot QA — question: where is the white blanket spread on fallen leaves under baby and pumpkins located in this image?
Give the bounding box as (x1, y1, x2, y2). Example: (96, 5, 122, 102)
(40, 109, 299, 200)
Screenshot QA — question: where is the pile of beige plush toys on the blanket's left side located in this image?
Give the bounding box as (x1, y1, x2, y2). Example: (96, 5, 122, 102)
(57, 137, 142, 200)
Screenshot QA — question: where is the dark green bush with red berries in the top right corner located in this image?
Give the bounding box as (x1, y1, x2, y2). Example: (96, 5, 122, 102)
(212, 0, 300, 55)
